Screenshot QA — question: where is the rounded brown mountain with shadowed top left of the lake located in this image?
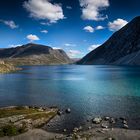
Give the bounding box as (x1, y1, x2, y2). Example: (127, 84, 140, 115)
(0, 43, 71, 65)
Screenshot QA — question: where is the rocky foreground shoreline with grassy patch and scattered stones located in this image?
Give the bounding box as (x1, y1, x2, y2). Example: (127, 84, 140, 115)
(0, 106, 140, 140)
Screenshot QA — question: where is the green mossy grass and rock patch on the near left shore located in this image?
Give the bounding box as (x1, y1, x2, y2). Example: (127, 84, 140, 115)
(0, 106, 58, 137)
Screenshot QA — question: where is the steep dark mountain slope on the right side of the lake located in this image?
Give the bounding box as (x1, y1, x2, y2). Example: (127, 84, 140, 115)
(77, 16, 140, 65)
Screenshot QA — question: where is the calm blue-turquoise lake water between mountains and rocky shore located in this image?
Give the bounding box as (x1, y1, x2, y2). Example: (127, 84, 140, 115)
(0, 65, 140, 129)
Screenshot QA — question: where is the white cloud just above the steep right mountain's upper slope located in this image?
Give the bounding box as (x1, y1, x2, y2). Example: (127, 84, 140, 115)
(108, 18, 128, 31)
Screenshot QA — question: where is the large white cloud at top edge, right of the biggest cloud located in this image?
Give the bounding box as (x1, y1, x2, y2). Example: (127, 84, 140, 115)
(79, 0, 109, 21)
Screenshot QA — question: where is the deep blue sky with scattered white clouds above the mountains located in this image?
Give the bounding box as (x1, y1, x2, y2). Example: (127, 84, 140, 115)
(0, 0, 140, 58)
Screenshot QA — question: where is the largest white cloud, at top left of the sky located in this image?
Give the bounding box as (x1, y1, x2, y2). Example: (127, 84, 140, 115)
(23, 0, 64, 23)
